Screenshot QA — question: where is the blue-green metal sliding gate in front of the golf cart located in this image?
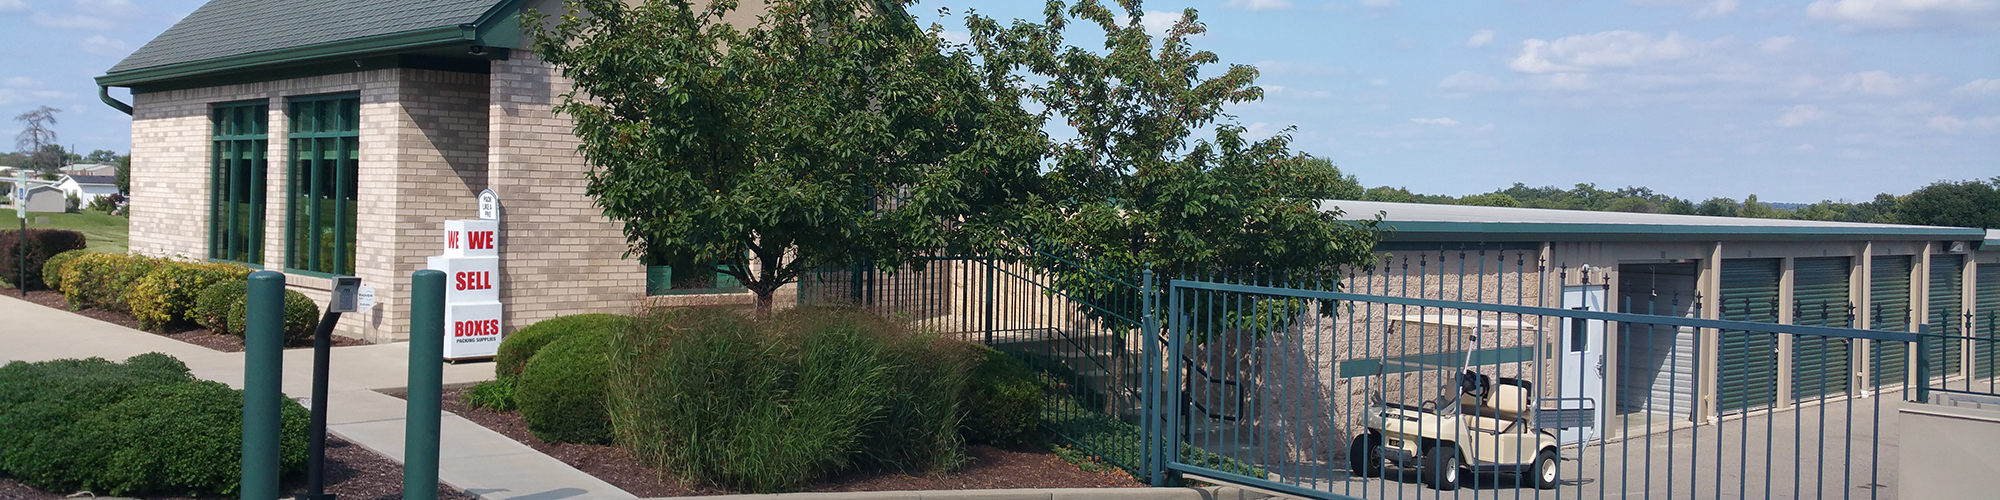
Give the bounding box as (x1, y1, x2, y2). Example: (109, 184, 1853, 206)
(1144, 280, 1936, 498)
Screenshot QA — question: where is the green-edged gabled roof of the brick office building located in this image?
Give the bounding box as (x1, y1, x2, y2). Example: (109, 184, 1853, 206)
(98, 0, 522, 86)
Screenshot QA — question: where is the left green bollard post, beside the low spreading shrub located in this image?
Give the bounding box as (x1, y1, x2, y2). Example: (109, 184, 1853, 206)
(238, 270, 284, 500)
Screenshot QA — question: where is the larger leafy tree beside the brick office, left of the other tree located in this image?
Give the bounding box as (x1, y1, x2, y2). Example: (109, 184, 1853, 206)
(528, 0, 1044, 312)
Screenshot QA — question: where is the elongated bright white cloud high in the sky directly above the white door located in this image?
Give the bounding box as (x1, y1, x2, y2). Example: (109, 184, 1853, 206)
(1508, 30, 1694, 74)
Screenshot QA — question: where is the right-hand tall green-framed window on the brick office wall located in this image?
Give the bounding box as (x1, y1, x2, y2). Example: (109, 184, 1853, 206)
(284, 94, 360, 274)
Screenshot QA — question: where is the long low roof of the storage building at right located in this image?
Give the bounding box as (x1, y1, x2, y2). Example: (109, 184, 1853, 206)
(1320, 200, 1988, 242)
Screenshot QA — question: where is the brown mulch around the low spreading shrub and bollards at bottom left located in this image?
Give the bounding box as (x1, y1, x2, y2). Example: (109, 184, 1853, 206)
(0, 436, 472, 500)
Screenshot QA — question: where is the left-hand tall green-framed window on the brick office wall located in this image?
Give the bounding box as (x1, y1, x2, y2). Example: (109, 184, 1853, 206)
(208, 102, 270, 264)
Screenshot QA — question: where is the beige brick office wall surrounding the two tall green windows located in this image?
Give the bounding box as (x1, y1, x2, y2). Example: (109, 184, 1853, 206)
(130, 68, 488, 342)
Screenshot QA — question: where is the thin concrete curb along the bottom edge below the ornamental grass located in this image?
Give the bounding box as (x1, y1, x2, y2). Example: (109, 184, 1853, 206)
(658, 486, 1272, 500)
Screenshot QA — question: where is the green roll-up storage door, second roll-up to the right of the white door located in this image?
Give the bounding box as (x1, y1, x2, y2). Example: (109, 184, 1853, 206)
(1716, 258, 1784, 412)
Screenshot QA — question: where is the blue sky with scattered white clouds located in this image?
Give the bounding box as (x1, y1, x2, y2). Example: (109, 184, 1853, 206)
(0, 0, 2000, 202)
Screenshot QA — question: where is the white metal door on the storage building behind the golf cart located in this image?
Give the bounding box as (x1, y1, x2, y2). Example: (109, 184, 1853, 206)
(1556, 286, 1604, 444)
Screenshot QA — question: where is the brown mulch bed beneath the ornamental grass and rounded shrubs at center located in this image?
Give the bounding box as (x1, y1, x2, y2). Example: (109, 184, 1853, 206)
(390, 388, 1144, 498)
